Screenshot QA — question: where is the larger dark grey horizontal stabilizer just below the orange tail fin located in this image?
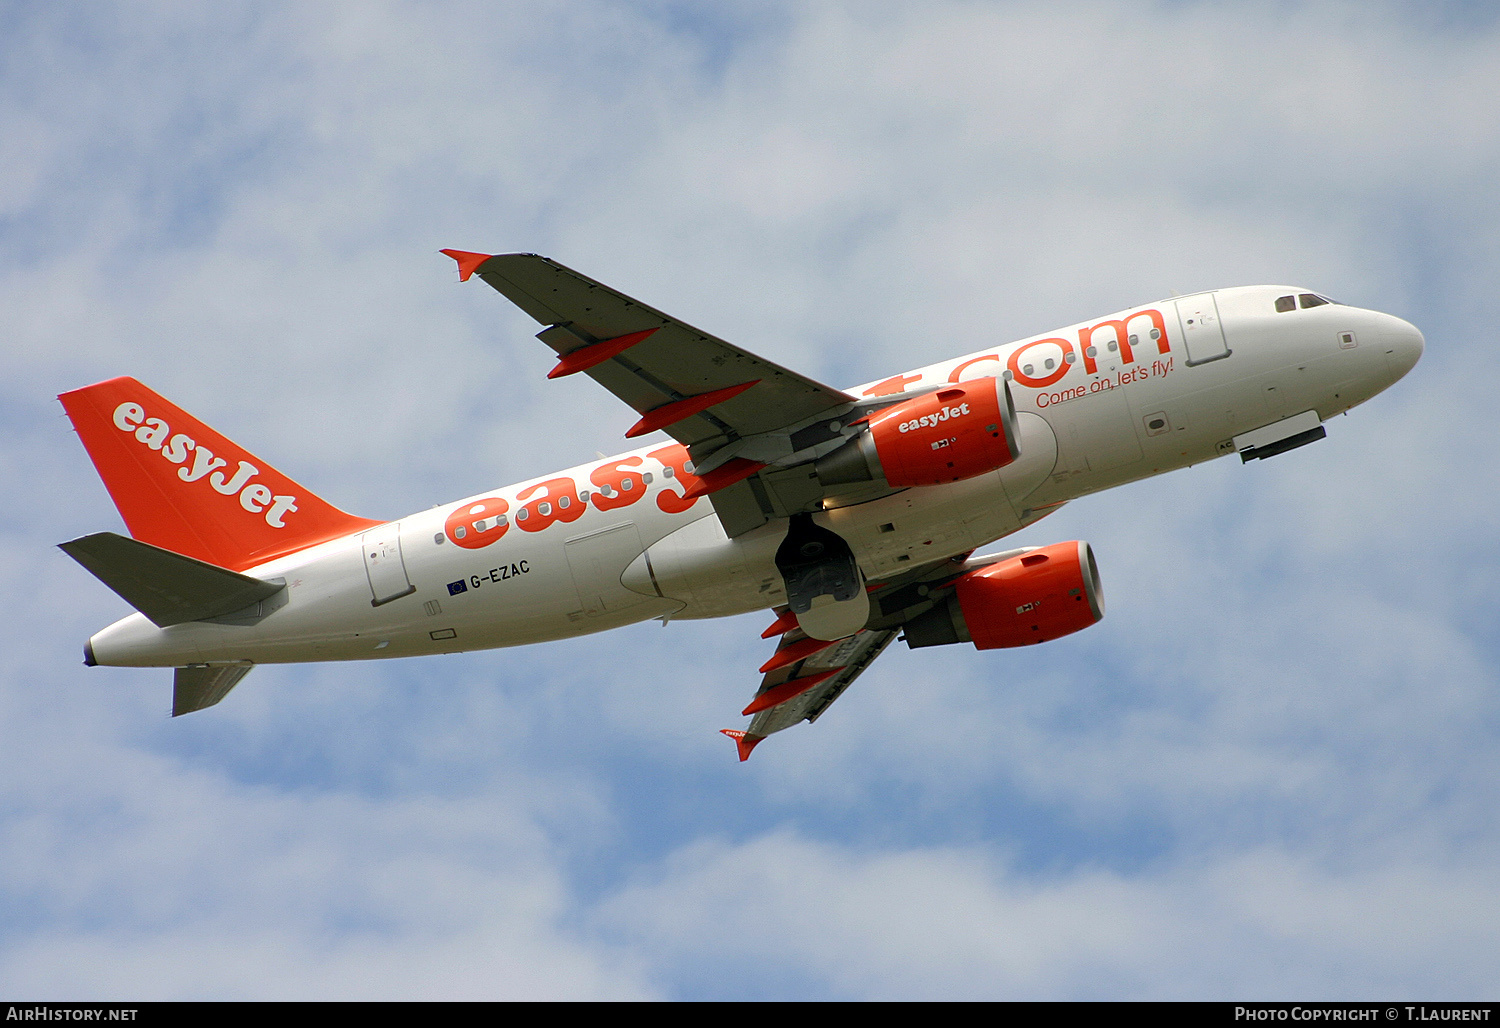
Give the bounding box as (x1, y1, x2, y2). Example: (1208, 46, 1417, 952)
(57, 531, 287, 624)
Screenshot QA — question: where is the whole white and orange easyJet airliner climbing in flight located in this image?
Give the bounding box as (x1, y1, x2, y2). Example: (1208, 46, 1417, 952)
(60, 251, 1424, 759)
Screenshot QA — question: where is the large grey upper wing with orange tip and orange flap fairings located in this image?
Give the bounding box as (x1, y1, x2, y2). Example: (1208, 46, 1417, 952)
(443, 251, 861, 536)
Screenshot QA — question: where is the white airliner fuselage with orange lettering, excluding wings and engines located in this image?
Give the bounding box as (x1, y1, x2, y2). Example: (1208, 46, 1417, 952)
(90, 280, 1422, 666)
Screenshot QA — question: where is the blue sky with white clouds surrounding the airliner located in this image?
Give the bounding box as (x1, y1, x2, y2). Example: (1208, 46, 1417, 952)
(0, 3, 1500, 999)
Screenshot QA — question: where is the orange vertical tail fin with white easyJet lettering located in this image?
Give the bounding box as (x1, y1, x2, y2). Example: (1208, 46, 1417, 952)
(59, 378, 381, 570)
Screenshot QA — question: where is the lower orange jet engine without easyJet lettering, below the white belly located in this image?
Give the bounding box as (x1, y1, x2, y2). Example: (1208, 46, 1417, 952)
(906, 540, 1104, 650)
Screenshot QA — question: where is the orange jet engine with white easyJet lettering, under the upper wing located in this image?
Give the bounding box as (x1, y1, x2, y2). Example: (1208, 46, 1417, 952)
(815, 378, 1020, 488)
